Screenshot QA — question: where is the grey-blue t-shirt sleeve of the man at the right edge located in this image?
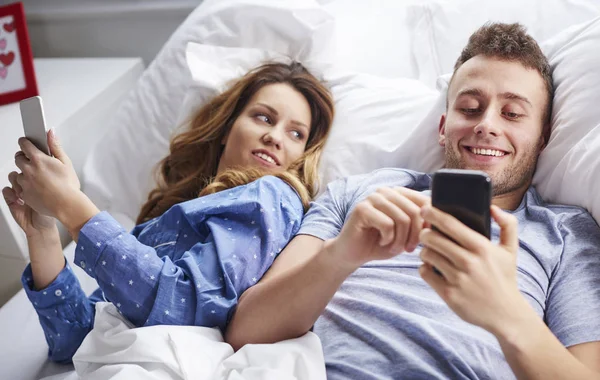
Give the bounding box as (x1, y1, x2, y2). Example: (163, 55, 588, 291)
(545, 212, 600, 347)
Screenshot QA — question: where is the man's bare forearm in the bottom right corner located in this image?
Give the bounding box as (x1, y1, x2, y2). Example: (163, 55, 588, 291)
(495, 300, 600, 380)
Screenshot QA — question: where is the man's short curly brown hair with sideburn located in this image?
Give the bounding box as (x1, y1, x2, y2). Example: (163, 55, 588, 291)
(454, 23, 554, 142)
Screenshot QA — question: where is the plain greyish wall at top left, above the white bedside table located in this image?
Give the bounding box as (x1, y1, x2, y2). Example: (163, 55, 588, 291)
(13, 0, 202, 64)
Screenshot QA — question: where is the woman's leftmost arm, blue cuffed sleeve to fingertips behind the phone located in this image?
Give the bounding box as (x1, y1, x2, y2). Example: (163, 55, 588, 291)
(2, 165, 98, 363)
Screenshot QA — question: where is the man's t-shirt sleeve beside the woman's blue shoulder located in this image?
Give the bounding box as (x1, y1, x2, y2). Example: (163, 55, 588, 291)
(298, 179, 348, 240)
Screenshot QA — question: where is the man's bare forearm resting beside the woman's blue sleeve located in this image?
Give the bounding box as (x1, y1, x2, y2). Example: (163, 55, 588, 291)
(225, 241, 355, 350)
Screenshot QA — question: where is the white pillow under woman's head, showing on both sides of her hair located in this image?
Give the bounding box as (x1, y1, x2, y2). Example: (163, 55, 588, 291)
(180, 43, 438, 188)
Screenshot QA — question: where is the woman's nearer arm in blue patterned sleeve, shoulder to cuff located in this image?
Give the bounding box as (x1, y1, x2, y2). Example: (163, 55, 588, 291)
(75, 177, 302, 329)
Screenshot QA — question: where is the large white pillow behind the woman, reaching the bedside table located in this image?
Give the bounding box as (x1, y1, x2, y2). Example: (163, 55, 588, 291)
(83, 0, 333, 220)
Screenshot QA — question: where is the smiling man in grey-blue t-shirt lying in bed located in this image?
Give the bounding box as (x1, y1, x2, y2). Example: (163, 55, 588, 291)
(226, 24, 600, 379)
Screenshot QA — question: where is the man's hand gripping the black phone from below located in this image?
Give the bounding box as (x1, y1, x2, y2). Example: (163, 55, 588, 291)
(420, 206, 527, 335)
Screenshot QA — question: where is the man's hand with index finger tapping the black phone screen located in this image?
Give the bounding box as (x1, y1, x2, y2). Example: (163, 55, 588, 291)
(331, 188, 431, 269)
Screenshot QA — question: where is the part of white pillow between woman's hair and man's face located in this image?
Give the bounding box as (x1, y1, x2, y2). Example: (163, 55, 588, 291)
(320, 70, 438, 183)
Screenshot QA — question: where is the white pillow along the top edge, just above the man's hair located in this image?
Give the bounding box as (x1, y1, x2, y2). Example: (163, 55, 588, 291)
(408, 0, 600, 86)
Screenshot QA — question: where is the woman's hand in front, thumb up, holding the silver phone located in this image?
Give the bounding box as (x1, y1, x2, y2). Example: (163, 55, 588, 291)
(9, 130, 81, 218)
